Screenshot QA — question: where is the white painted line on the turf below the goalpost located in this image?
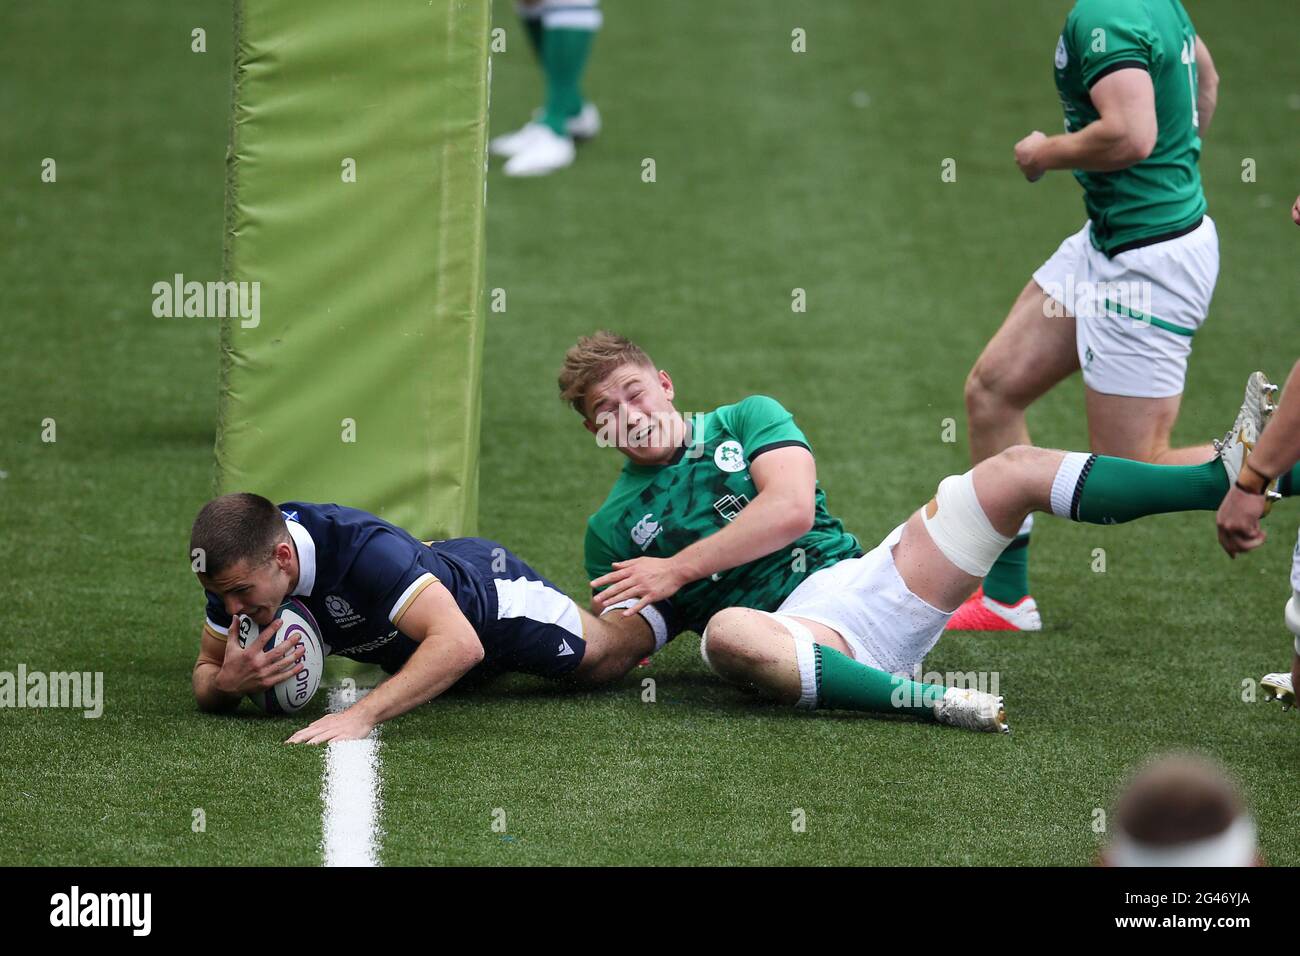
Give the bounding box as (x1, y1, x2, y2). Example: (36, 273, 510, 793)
(321, 687, 380, 866)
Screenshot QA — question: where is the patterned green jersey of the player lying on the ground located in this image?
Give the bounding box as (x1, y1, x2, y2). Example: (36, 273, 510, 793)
(585, 395, 862, 633)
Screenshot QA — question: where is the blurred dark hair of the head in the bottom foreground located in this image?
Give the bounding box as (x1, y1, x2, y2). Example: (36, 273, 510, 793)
(1115, 756, 1244, 847)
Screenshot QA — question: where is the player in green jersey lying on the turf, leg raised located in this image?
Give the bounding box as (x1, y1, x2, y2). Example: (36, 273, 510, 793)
(559, 332, 1273, 731)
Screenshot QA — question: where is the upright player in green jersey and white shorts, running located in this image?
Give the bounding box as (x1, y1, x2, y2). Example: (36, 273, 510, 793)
(949, 0, 1219, 631)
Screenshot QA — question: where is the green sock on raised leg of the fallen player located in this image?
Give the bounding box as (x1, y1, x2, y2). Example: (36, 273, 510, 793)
(1070, 455, 1227, 524)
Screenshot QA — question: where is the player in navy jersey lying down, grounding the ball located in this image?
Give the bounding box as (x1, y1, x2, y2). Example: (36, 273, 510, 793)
(190, 493, 662, 744)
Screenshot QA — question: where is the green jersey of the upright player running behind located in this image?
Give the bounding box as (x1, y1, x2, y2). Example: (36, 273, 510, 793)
(1056, 0, 1205, 256)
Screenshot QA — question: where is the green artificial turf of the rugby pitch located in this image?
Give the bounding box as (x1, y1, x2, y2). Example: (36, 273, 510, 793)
(0, 0, 1300, 865)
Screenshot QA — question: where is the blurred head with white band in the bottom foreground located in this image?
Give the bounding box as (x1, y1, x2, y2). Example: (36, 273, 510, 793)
(1102, 754, 1261, 866)
